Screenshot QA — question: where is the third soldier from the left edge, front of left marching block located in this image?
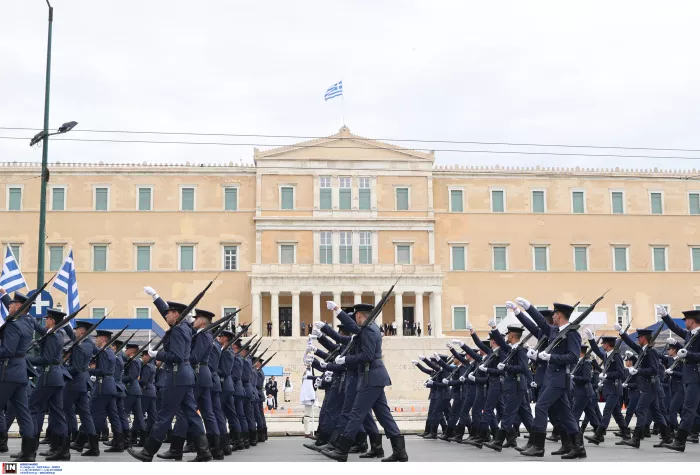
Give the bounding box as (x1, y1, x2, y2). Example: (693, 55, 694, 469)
(63, 321, 100, 457)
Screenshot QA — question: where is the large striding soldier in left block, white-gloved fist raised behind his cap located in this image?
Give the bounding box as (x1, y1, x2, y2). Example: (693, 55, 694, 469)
(128, 300, 211, 462)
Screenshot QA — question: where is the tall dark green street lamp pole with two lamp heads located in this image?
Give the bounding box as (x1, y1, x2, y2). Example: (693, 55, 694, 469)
(29, 0, 78, 289)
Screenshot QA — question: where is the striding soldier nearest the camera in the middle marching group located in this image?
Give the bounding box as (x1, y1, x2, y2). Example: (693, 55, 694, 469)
(320, 304, 408, 462)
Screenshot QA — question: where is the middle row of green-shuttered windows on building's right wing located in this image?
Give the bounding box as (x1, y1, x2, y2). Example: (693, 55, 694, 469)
(450, 245, 700, 272)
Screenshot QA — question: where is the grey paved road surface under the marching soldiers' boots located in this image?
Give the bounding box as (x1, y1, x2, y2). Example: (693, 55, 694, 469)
(6, 436, 700, 463)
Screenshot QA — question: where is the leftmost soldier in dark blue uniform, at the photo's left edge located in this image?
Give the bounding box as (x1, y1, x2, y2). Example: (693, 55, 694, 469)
(0, 288, 38, 462)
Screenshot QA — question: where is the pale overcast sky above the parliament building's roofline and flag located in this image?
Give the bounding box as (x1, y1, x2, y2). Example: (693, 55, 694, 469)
(0, 0, 700, 169)
